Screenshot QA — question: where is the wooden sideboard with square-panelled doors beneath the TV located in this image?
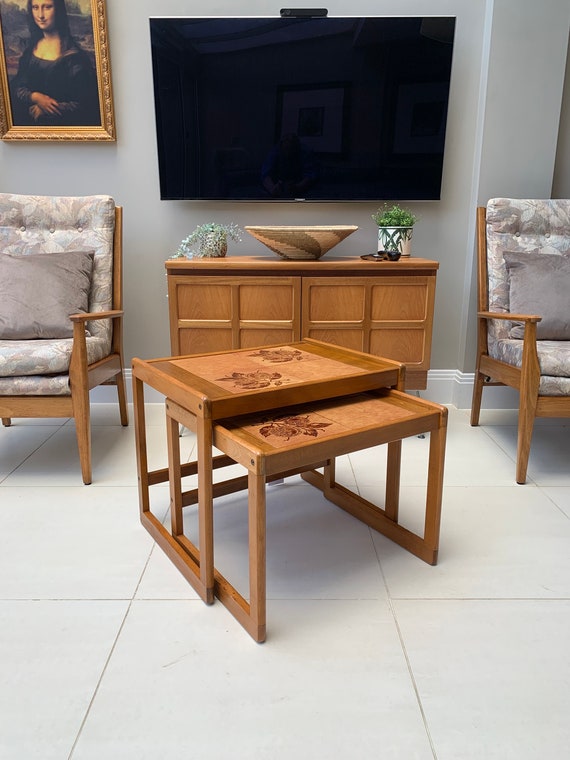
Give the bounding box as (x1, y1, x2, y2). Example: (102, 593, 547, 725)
(165, 256, 439, 389)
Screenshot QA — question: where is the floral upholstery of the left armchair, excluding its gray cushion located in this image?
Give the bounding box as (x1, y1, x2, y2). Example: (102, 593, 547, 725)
(0, 193, 115, 395)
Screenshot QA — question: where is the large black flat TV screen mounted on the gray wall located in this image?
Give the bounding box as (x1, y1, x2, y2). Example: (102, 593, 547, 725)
(150, 17, 455, 201)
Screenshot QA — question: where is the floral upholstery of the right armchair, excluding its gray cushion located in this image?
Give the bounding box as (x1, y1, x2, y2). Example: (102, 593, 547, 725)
(486, 198, 570, 396)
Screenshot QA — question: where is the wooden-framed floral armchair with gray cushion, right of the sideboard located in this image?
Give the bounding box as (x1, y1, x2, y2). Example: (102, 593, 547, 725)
(471, 198, 570, 483)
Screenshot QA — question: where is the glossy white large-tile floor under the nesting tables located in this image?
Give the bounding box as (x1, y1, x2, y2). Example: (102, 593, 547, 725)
(0, 405, 570, 760)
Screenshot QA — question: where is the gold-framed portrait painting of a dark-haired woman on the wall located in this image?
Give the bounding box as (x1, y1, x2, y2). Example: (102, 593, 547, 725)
(0, 0, 115, 141)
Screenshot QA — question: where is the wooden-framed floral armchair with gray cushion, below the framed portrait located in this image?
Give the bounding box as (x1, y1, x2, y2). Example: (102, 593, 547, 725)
(0, 193, 128, 484)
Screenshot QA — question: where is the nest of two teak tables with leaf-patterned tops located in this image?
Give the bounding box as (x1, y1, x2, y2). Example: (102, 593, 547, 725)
(133, 339, 447, 641)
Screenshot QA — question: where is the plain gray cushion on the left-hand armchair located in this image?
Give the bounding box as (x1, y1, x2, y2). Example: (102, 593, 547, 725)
(0, 251, 93, 340)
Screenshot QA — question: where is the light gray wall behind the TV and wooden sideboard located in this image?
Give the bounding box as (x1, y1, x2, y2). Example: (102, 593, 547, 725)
(0, 0, 570, 372)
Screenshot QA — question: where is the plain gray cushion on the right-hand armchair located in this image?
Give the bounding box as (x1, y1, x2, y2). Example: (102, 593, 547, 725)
(503, 251, 570, 340)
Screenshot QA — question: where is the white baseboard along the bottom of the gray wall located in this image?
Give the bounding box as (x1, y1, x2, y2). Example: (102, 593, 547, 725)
(91, 369, 519, 409)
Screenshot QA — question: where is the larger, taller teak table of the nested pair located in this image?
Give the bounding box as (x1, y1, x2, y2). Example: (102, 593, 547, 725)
(132, 339, 405, 616)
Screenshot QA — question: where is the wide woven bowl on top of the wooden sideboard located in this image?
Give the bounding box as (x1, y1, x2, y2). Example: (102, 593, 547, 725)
(244, 224, 358, 261)
